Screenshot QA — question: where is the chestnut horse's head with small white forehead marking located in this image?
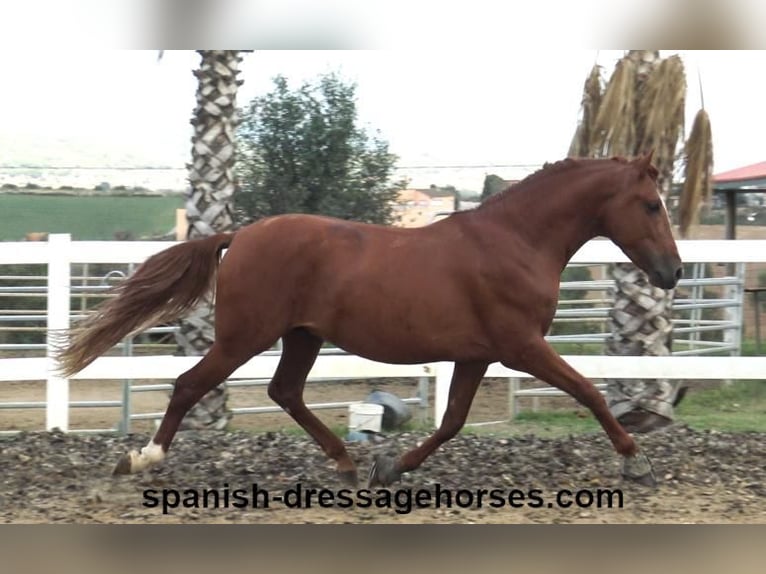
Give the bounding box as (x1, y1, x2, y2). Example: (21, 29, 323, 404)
(599, 152, 683, 289)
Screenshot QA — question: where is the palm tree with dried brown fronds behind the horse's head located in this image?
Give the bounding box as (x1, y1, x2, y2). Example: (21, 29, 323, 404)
(569, 50, 713, 432)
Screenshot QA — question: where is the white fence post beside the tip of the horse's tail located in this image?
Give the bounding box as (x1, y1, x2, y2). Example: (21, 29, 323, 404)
(45, 233, 72, 432)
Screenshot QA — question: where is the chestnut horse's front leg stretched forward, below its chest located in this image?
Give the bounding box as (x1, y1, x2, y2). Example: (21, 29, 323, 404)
(503, 338, 656, 486)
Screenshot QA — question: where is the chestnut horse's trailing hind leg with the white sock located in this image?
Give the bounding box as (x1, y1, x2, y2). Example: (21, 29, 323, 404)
(114, 343, 252, 474)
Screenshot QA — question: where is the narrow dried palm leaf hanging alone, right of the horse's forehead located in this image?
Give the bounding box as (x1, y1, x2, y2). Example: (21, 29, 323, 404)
(679, 109, 713, 237)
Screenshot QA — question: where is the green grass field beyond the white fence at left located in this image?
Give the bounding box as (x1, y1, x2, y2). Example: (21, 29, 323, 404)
(0, 193, 184, 241)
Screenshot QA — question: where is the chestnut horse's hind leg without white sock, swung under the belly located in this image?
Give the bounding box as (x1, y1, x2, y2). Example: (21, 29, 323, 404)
(268, 329, 357, 486)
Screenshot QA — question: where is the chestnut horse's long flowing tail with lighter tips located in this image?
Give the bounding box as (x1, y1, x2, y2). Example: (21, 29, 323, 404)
(57, 233, 234, 376)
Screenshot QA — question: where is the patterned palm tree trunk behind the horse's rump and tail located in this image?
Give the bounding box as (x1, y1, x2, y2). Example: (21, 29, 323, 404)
(176, 50, 242, 430)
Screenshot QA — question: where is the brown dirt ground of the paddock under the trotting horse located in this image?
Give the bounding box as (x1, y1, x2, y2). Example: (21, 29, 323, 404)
(0, 381, 766, 523)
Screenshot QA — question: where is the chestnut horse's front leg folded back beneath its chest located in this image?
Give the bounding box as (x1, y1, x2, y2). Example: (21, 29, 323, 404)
(368, 363, 489, 487)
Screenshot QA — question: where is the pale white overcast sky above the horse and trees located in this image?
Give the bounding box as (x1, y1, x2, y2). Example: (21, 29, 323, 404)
(0, 46, 766, 190)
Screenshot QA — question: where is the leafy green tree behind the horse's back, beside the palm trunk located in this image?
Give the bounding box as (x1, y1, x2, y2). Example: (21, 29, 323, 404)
(234, 74, 405, 224)
